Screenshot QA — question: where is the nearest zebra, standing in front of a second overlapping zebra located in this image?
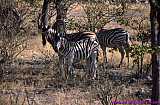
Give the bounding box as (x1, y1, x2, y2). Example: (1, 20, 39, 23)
(57, 34, 99, 78)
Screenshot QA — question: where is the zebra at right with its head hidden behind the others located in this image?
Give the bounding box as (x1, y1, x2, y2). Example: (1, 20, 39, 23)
(97, 28, 129, 67)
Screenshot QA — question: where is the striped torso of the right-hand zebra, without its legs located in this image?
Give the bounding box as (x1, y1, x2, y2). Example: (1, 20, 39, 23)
(97, 28, 129, 48)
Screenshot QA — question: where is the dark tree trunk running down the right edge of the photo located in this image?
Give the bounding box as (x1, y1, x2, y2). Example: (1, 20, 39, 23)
(149, 0, 160, 105)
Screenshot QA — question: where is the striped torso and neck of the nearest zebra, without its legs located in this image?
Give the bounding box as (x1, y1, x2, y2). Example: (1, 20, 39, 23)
(58, 38, 99, 61)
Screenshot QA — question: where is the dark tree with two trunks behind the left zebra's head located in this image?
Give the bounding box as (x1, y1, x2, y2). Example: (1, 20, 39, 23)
(39, 0, 72, 41)
